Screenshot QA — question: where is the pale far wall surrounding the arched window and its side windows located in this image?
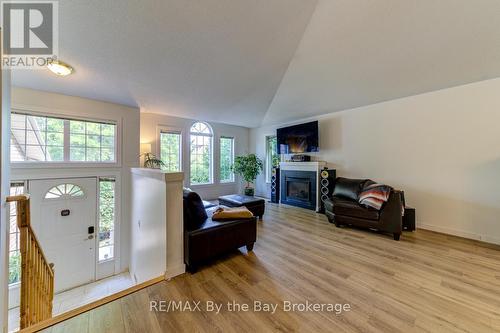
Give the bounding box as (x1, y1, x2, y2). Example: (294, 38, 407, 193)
(141, 113, 249, 200)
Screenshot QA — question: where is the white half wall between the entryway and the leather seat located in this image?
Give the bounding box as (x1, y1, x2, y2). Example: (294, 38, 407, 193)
(130, 168, 186, 283)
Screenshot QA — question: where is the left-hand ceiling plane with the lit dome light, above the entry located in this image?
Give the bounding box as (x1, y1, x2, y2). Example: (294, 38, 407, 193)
(13, 0, 316, 127)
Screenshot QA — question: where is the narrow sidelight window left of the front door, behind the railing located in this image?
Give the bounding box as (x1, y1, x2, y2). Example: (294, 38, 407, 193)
(9, 182, 24, 284)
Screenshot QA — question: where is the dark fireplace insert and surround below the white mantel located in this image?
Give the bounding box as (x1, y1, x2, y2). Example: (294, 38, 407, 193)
(280, 170, 317, 210)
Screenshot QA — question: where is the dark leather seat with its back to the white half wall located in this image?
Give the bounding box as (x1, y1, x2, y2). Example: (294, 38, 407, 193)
(183, 191, 257, 273)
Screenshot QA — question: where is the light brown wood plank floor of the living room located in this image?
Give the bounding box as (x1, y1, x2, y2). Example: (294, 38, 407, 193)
(40, 204, 500, 333)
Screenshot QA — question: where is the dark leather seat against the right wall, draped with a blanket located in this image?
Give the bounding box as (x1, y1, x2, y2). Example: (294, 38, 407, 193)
(325, 177, 403, 240)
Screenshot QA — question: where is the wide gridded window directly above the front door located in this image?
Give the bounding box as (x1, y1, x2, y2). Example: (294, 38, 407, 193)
(10, 113, 116, 163)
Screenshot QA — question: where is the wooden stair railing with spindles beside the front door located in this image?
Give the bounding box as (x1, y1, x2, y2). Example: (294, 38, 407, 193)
(7, 195, 54, 329)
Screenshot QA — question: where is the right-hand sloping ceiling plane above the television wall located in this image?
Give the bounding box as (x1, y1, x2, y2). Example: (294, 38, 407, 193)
(263, 0, 500, 124)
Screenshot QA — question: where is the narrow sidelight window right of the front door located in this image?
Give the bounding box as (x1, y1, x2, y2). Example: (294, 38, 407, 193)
(99, 178, 116, 261)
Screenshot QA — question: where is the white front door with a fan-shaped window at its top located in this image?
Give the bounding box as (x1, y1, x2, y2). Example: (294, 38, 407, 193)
(28, 178, 97, 292)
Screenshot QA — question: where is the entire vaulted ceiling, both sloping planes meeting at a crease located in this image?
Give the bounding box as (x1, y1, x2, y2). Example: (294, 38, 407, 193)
(13, 0, 500, 127)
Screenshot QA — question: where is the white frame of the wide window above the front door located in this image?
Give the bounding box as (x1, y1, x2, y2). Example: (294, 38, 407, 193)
(9, 106, 122, 169)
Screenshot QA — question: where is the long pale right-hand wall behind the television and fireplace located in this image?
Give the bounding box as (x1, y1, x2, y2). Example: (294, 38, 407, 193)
(250, 79, 500, 244)
